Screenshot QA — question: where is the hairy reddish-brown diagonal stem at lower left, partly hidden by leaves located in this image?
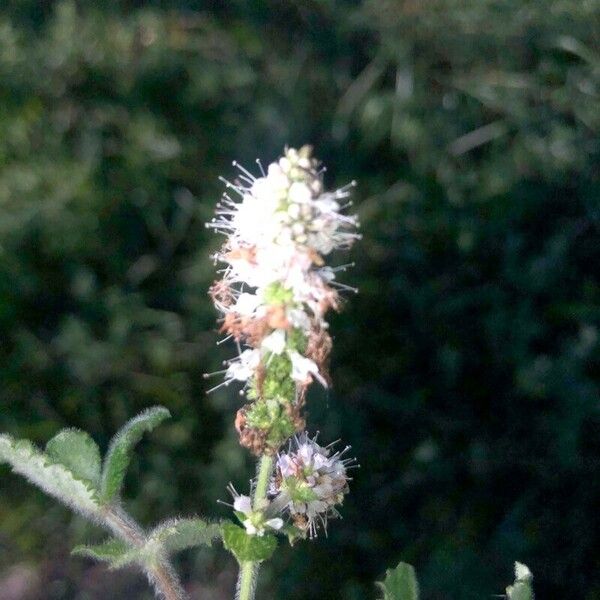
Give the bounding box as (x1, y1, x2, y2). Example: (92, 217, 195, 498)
(103, 506, 188, 600)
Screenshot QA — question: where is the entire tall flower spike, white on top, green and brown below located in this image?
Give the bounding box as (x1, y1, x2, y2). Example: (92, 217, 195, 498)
(207, 146, 359, 455)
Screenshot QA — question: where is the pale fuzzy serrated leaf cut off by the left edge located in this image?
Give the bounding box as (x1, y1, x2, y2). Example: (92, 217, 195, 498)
(0, 434, 101, 520)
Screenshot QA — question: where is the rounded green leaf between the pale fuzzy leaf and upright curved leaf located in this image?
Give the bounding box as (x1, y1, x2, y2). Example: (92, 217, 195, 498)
(46, 429, 100, 487)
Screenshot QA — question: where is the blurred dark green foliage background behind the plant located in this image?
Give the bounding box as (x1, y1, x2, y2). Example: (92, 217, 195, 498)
(0, 0, 600, 600)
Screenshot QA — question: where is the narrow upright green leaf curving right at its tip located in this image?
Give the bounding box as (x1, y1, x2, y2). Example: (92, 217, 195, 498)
(100, 406, 171, 502)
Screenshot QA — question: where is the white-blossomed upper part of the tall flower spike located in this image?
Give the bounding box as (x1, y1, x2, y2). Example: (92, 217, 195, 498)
(208, 147, 359, 394)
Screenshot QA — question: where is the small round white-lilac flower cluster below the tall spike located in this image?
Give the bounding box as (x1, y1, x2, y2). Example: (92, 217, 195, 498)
(269, 433, 355, 538)
